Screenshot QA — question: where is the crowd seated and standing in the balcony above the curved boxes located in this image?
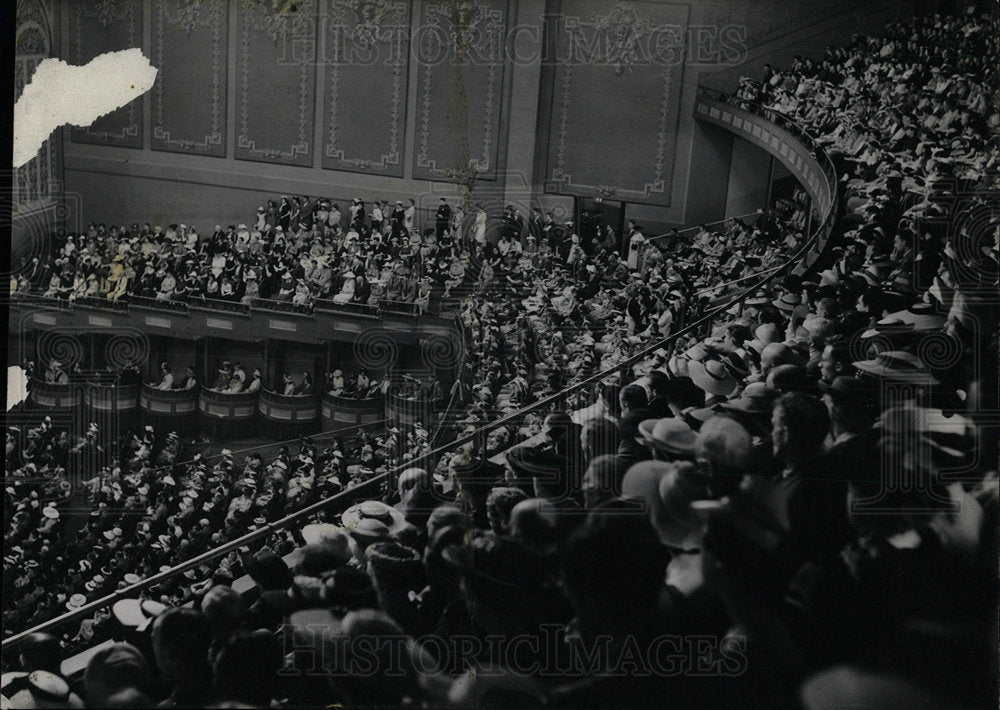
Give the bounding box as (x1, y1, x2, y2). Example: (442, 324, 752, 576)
(11, 197, 548, 313)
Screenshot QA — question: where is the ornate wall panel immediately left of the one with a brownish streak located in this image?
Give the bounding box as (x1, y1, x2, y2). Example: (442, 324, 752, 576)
(323, 0, 410, 177)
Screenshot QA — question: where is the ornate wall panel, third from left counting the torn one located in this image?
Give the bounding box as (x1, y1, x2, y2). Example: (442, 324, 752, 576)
(233, 0, 318, 166)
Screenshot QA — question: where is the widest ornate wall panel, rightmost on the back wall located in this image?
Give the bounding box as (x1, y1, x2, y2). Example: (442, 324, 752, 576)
(546, 0, 688, 205)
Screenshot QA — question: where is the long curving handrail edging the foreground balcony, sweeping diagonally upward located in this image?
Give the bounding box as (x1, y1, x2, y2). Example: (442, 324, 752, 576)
(0, 92, 838, 650)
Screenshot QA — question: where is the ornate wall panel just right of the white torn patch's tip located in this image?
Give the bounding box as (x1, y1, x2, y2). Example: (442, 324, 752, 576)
(151, 0, 230, 156)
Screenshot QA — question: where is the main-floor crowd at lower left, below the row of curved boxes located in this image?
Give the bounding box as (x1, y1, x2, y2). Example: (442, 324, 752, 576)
(3, 417, 429, 668)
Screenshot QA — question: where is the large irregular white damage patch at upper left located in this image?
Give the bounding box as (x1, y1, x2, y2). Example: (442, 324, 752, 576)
(14, 48, 156, 168)
